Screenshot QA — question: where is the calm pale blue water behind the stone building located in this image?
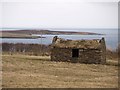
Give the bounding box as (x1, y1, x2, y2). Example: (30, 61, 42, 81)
(2, 29, 118, 50)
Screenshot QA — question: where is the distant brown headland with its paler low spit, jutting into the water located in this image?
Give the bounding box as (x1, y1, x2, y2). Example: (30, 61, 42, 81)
(0, 29, 104, 39)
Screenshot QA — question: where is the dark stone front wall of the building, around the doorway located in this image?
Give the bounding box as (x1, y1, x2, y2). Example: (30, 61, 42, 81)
(51, 47, 105, 64)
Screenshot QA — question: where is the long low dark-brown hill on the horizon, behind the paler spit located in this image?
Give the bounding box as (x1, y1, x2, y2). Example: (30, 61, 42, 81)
(2, 30, 101, 35)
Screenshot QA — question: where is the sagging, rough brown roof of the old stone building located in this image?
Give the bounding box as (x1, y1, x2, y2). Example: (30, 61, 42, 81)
(52, 38, 101, 49)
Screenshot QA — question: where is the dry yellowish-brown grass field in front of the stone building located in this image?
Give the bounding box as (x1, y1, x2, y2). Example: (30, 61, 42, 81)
(2, 54, 118, 88)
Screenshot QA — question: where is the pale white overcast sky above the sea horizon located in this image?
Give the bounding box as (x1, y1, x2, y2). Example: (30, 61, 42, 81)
(0, 0, 118, 28)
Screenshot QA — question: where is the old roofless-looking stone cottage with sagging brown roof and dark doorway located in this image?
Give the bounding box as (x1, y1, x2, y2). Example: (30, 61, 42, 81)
(51, 36, 106, 64)
